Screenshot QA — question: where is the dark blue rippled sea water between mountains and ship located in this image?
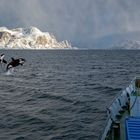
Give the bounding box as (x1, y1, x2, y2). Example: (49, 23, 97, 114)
(0, 50, 140, 140)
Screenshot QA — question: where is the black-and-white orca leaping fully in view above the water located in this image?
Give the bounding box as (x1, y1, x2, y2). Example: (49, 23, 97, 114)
(6, 58, 26, 71)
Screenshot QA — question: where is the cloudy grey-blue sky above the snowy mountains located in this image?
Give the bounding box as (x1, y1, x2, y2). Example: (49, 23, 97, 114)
(0, 0, 140, 47)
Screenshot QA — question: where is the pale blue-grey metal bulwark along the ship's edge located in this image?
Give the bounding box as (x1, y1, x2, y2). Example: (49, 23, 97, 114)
(99, 78, 136, 140)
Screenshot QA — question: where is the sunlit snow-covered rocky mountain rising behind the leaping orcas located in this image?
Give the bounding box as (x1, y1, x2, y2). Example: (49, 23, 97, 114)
(0, 27, 72, 49)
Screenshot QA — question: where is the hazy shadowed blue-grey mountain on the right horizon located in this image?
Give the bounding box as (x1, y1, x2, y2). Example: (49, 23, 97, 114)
(89, 31, 140, 49)
